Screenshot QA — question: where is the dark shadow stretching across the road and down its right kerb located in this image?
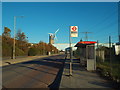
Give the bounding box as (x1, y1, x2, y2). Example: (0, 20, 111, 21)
(22, 58, 65, 89)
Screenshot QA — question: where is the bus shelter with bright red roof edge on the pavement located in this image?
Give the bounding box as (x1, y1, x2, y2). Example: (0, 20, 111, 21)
(75, 41, 96, 71)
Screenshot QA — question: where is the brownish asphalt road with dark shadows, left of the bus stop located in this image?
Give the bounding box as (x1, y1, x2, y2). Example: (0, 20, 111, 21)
(2, 55, 65, 88)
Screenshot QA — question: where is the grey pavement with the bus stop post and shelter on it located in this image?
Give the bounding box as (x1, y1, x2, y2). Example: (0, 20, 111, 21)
(59, 58, 113, 89)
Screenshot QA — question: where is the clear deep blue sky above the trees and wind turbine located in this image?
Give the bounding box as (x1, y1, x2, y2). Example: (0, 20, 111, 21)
(2, 2, 118, 43)
